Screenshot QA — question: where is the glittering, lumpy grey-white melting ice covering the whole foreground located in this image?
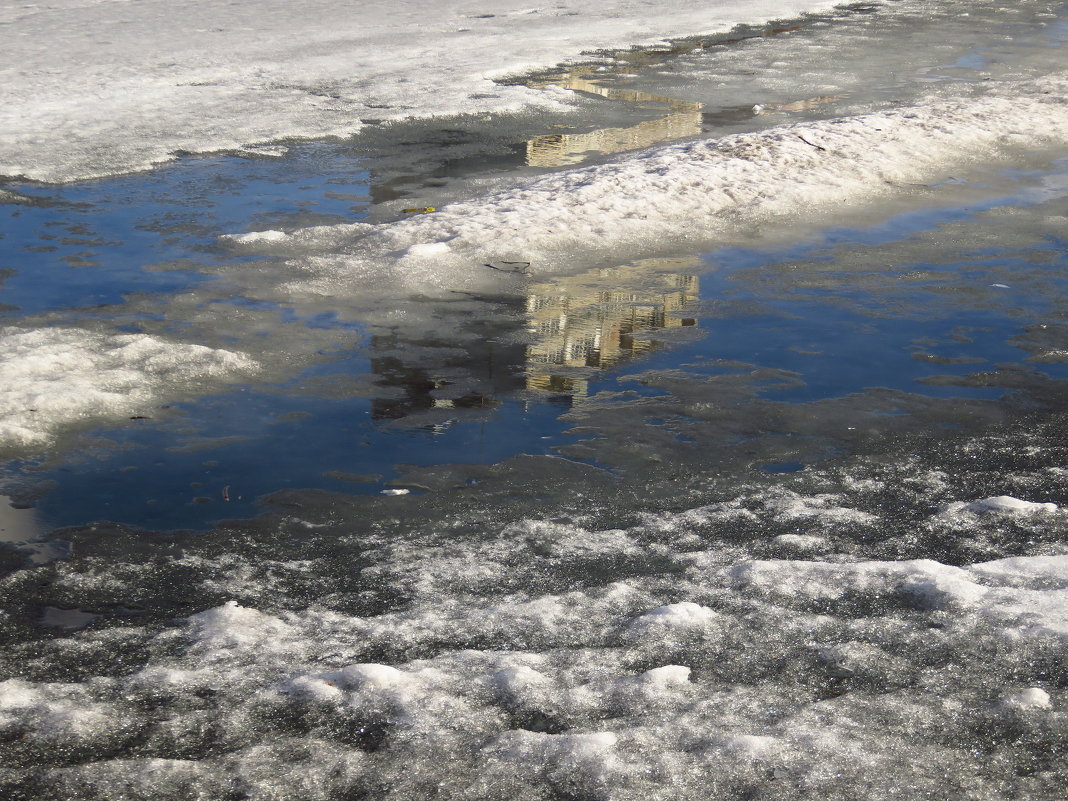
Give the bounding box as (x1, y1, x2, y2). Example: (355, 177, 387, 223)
(6, 418, 1068, 801)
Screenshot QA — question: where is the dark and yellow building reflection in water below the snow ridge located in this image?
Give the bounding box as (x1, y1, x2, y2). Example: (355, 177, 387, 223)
(371, 258, 698, 431)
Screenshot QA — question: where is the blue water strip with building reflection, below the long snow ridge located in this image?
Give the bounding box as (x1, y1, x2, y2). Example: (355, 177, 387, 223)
(4, 166, 1068, 536)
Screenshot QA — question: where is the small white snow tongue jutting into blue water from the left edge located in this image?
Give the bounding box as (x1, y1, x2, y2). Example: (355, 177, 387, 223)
(0, 326, 256, 450)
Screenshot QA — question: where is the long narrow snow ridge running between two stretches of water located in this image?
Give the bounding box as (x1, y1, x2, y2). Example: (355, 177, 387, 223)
(229, 79, 1068, 294)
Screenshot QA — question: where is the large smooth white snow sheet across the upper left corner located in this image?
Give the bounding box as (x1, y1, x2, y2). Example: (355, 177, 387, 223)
(0, 0, 834, 182)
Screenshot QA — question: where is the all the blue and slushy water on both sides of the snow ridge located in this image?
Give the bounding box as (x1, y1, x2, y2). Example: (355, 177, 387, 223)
(0, 2, 1066, 538)
